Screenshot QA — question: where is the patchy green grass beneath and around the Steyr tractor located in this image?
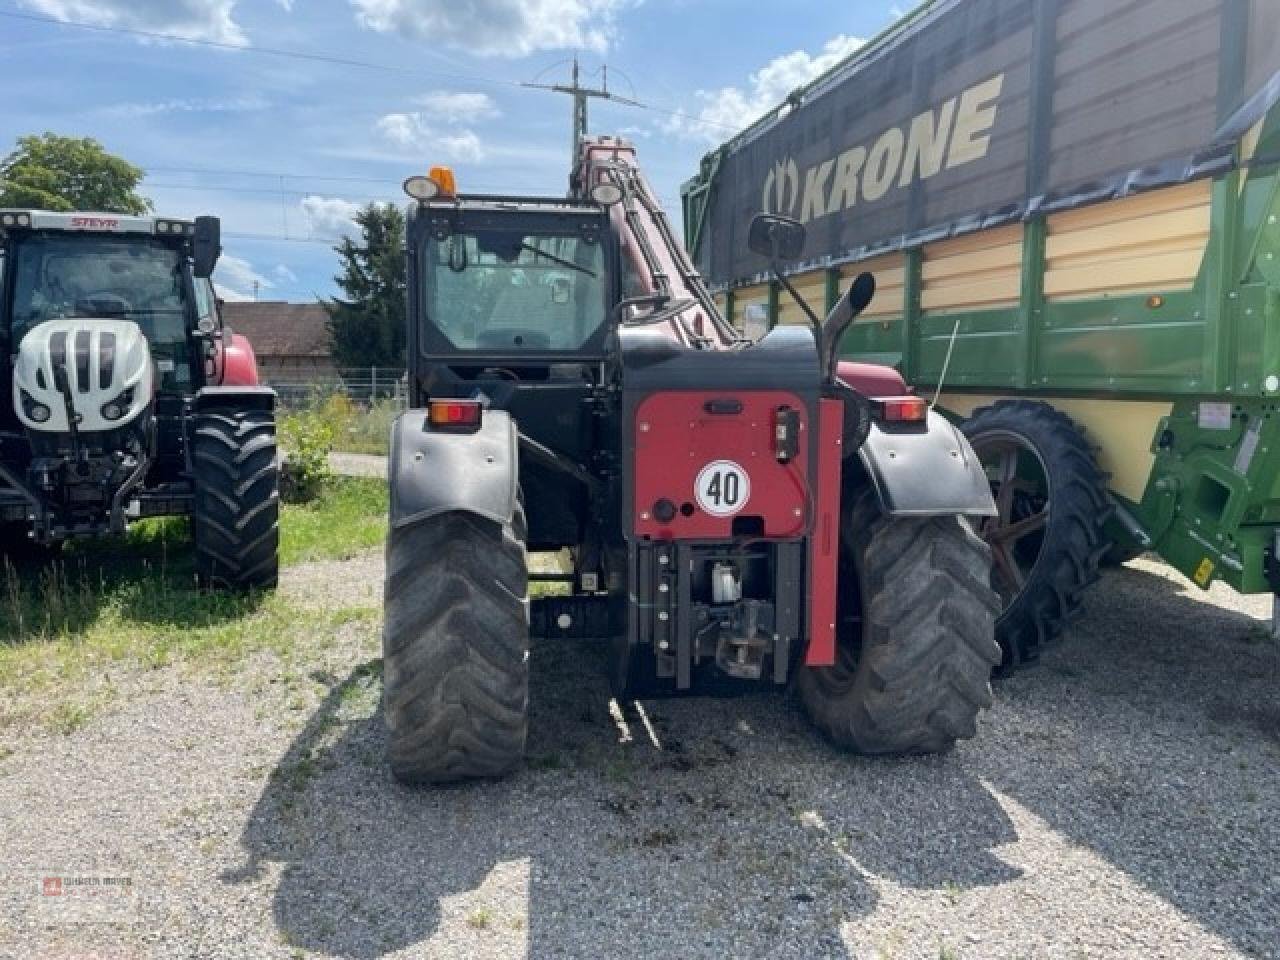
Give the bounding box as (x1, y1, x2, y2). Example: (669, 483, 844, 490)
(0, 479, 387, 749)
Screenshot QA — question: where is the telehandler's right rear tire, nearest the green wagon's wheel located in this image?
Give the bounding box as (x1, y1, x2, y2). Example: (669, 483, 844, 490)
(796, 489, 1000, 754)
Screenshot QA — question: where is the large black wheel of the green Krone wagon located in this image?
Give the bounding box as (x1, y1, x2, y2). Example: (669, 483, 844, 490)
(961, 399, 1114, 669)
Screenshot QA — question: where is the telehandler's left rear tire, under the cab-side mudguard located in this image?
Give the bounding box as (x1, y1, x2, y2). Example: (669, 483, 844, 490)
(383, 507, 529, 785)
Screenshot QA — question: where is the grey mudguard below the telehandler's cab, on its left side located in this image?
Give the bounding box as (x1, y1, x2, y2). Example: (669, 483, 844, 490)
(388, 410, 520, 527)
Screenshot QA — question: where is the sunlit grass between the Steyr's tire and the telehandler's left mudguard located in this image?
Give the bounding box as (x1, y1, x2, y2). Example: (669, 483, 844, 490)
(280, 476, 388, 566)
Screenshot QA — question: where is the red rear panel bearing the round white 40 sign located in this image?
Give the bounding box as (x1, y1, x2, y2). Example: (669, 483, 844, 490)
(634, 390, 813, 540)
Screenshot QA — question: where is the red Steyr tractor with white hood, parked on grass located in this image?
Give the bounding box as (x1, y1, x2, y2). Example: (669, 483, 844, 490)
(0, 210, 279, 588)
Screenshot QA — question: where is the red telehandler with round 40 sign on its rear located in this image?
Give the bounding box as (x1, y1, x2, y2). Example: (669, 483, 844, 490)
(383, 144, 1000, 782)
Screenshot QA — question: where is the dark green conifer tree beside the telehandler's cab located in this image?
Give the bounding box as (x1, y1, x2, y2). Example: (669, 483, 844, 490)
(325, 204, 406, 369)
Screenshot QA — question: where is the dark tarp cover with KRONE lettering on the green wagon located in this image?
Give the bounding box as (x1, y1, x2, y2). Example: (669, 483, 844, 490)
(685, 0, 1280, 285)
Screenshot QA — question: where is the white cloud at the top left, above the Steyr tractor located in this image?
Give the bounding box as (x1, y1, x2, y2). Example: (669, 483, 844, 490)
(19, 0, 248, 46)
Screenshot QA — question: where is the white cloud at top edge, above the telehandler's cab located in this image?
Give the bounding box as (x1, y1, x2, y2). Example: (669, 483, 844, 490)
(349, 0, 631, 58)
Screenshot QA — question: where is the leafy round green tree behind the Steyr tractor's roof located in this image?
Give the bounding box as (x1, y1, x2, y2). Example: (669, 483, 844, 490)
(0, 133, 151, 214)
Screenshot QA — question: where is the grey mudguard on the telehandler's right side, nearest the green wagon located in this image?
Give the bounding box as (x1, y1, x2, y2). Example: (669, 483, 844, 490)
(858, 410, 996, 517)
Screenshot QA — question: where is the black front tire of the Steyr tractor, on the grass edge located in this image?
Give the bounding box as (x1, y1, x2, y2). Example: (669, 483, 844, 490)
(191, 410, 280, 590)
